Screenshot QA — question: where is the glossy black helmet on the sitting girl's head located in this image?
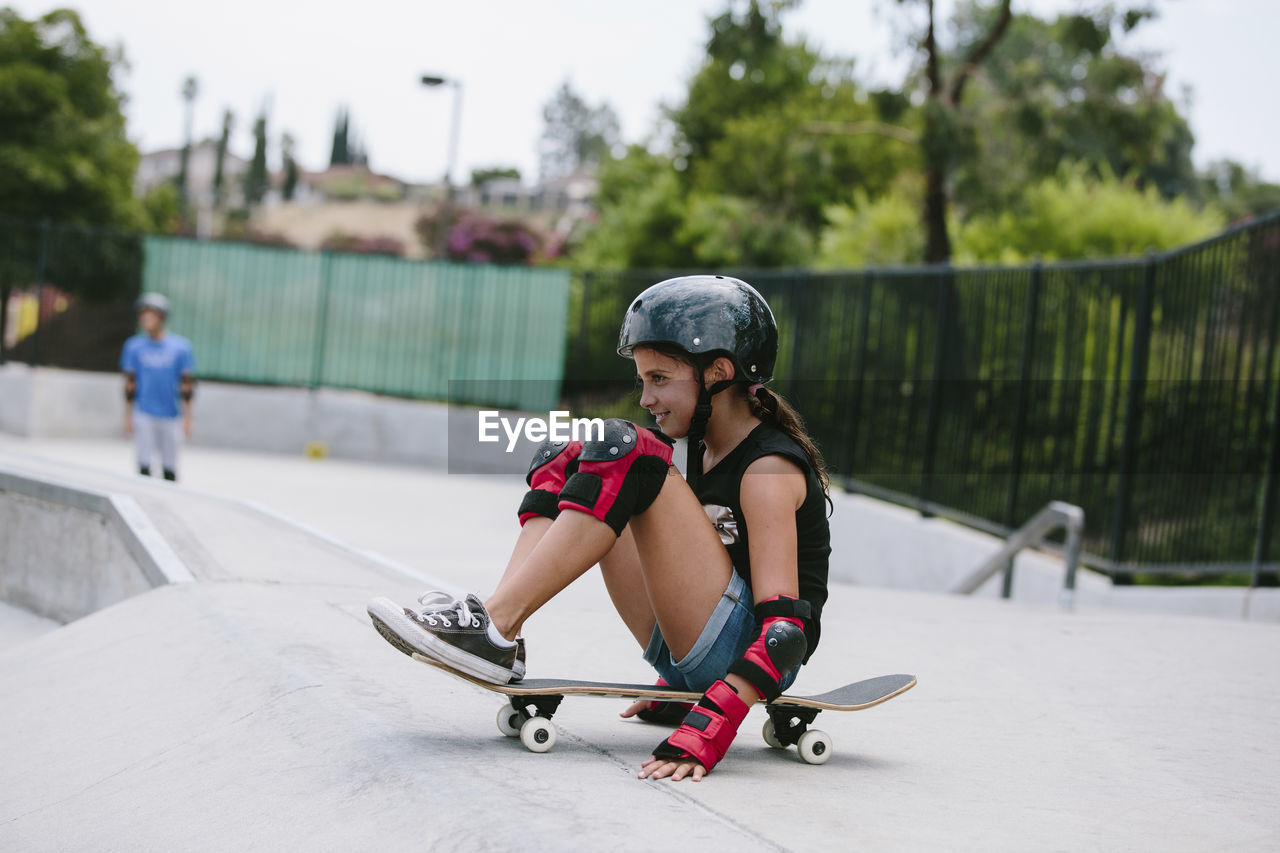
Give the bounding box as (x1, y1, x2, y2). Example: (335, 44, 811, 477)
(618, 275, 778, 383)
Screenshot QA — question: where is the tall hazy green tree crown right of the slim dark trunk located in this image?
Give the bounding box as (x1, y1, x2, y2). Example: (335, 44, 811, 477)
(948, 0, 1201, 213)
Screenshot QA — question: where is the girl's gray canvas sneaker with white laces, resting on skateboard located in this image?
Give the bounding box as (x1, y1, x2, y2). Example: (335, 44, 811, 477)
(367, 592, 525, 684)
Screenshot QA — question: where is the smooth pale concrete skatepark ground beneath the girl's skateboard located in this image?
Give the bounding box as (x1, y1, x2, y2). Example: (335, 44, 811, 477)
(0, 435, 1280, 850)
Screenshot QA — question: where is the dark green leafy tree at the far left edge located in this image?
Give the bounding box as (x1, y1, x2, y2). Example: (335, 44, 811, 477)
(0, 9, 143, 228)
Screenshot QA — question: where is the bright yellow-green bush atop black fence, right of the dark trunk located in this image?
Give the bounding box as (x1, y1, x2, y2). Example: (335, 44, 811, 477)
(956, 167, 1224, 264)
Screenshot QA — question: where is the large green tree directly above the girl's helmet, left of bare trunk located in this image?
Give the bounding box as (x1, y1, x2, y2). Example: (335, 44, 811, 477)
(575, 1, 919, 269)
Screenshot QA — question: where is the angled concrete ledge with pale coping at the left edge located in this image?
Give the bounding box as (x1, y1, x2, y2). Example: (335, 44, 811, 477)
(0, 470, 193, 622)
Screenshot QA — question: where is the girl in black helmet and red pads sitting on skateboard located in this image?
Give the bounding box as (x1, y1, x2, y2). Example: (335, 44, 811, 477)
(369, 275, 831, 781)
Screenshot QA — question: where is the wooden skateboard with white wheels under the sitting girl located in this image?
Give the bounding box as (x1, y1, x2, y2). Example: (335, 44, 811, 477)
(413, 653, 915, 765)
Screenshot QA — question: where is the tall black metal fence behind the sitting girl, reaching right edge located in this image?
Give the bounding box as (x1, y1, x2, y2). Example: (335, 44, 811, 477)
(566, 216, 1280, 578)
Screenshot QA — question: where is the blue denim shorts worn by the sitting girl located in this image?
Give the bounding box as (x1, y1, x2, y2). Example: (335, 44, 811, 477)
(644, 571, 800, 693)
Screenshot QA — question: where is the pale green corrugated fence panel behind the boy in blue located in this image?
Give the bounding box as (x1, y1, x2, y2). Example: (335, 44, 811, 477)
(143, 237, 570, 410)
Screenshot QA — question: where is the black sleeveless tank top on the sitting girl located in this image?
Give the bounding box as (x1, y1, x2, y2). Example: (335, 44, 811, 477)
(698, 424, 831, 661)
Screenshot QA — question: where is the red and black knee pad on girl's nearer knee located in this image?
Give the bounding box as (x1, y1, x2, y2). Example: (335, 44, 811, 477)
(557, 418, 671, 535)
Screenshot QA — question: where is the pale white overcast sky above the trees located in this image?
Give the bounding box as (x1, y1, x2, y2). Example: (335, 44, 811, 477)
(10, 0, 1280, 182)
